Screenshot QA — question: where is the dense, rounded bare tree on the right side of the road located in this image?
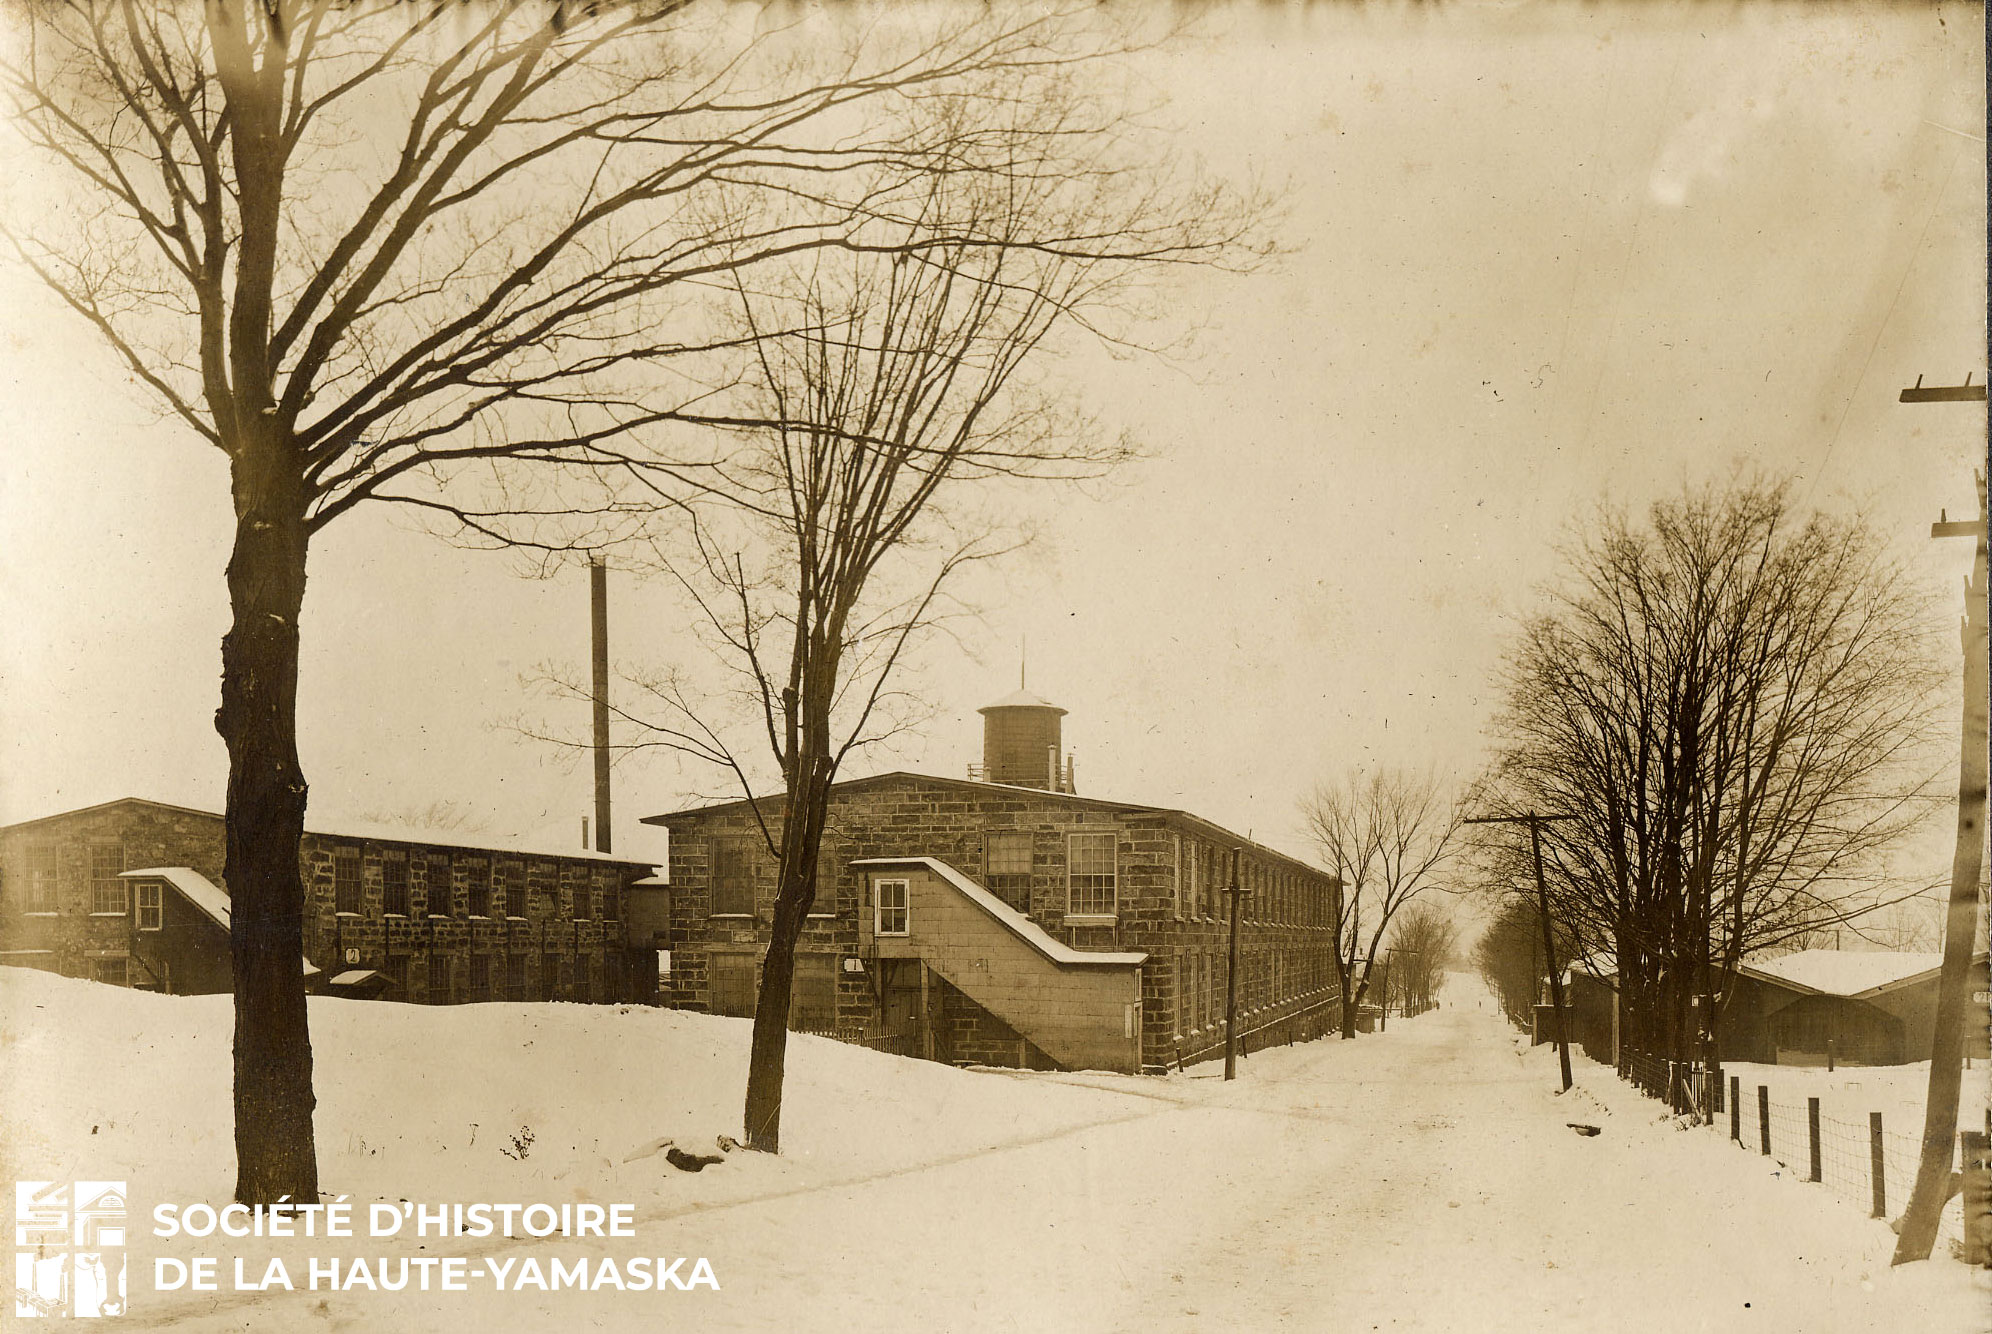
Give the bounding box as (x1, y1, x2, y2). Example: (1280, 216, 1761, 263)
(1494, 480, 1934, 1059)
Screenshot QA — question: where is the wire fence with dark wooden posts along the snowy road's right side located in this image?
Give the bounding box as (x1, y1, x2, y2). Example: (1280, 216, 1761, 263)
(1619, 1051, 1992, 1252)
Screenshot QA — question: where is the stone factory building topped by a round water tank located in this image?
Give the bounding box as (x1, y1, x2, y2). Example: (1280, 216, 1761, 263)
(631, 693, 1341, 1071)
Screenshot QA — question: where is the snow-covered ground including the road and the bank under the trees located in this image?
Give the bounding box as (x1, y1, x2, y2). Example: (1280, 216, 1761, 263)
(0, 970, 1988, 1334)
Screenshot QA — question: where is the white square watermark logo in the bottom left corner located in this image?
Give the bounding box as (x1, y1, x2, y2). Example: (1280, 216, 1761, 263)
(14, 1181, 125, 1316)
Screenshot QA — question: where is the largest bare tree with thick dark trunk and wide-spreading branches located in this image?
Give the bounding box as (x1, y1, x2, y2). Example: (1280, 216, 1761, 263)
(0, 0, 1227, 1203)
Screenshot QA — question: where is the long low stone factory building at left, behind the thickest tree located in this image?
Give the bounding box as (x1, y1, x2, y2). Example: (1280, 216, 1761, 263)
(0, 798, 655, 1005)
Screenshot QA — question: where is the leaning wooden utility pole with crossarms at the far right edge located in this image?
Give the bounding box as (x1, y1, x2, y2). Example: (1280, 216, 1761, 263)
(1890, 453, 1986, 1264)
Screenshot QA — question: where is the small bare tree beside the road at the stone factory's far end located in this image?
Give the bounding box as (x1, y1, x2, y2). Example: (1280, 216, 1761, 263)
(1301, 769, 1464, 1037)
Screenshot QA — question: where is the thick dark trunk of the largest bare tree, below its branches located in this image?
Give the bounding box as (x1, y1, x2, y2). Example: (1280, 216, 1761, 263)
(215, 440, 319, 1205)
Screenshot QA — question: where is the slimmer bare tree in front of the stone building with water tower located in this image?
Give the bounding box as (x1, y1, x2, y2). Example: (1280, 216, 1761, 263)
(521, 99, 1257, 1151)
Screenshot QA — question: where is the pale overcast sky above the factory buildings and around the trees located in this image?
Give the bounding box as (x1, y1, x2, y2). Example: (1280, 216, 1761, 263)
(0, 4, 1986, 888)
